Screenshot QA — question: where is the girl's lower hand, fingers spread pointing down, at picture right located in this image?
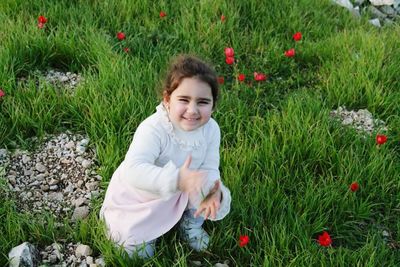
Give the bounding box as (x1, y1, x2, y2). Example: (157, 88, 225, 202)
(194, 180, 222, 220)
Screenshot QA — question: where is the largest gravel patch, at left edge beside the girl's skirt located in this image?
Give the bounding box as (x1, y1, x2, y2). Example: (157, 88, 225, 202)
(0, 133, 101, 221)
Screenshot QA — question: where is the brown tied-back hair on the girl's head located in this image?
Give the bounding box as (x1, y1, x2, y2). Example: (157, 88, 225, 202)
(162, 55, 219, 108)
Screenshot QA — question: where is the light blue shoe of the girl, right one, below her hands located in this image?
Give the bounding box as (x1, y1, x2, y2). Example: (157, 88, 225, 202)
(179, 209, 210, 251)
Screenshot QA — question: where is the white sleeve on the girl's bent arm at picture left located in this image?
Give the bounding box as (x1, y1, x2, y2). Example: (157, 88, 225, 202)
(120, 123, 179, 199)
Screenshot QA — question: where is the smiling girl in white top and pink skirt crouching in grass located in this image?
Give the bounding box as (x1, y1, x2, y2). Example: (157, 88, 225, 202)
(100, 55, 231, 258)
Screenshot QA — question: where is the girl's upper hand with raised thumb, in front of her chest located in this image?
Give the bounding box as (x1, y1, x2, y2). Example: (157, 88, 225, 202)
(178, 155, 207, 193)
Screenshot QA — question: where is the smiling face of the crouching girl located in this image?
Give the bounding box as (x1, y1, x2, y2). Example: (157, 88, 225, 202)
(164, 78, 213, 131)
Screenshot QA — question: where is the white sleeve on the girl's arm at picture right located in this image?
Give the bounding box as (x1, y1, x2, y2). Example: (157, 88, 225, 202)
(199, 120, 231, 221)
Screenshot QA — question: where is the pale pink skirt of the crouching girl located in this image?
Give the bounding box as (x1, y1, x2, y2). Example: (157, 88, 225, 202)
(100, 169, 189, 246)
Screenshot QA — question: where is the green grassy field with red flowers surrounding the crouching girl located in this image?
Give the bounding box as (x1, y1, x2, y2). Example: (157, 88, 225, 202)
(0, 0, 400, 266)
